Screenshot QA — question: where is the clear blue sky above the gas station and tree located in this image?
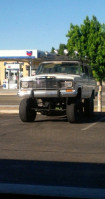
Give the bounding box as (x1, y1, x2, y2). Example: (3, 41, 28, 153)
(0, 0, 105, 51)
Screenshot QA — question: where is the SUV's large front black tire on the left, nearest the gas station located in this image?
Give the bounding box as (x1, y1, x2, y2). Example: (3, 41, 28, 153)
(19, 98, 36, 122)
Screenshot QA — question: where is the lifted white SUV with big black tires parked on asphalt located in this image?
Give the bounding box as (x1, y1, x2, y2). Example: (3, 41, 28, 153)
(18, 60, 97, 123)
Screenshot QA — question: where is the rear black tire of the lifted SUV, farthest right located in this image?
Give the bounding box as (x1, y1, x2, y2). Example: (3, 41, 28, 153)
(84, 97, 94, 116)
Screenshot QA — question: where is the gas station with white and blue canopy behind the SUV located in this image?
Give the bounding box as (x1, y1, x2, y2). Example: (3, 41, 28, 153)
(0, 50, 45, 89)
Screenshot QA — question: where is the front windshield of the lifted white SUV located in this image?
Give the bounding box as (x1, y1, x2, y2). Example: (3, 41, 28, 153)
(36, 63, 80, 75)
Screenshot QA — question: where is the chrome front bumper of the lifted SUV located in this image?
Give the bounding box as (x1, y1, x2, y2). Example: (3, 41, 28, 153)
(17, 89, 77, 98)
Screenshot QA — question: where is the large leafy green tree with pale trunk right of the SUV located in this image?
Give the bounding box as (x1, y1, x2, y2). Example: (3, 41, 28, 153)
(66, 16, 105, 111)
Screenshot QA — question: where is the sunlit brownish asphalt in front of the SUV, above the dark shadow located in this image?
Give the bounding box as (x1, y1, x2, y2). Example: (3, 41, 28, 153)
(0, 112, 105, 163)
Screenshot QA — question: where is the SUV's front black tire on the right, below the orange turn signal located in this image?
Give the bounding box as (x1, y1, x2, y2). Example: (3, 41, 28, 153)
(66, 100, 83, 123)
